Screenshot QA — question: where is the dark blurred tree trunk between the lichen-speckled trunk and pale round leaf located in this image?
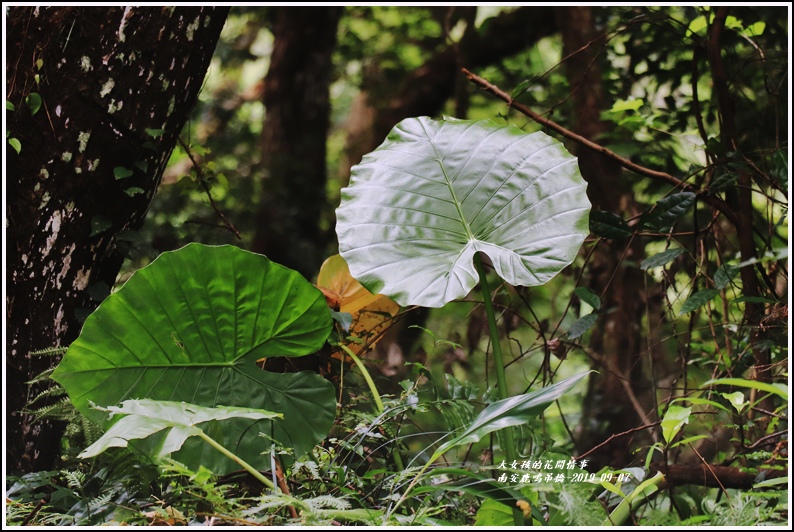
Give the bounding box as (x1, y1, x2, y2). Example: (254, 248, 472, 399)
(253, 7, 343, 277)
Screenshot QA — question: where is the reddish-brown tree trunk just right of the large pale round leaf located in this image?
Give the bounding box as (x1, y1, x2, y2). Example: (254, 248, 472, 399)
(557, 7, 648, 470)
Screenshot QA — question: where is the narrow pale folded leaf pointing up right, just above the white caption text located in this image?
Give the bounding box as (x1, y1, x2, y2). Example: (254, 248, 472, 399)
(430, 371, 590, 462)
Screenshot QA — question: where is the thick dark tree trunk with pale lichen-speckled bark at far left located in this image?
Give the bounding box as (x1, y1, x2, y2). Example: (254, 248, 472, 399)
(6, 7, 229, 472)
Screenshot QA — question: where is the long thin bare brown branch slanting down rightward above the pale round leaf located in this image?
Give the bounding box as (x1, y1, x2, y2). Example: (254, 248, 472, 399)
(461, 68, 739, 225)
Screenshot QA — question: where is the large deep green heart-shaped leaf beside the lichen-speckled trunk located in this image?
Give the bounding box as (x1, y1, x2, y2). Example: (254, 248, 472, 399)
(53, 244, 336, 474)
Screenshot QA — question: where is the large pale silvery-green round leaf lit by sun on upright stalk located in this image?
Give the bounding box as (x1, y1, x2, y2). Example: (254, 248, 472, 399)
(336, 117, 590, 307)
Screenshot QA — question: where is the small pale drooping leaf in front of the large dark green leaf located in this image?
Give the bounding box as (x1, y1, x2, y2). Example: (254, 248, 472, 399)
(78, 399, 282, 458)
